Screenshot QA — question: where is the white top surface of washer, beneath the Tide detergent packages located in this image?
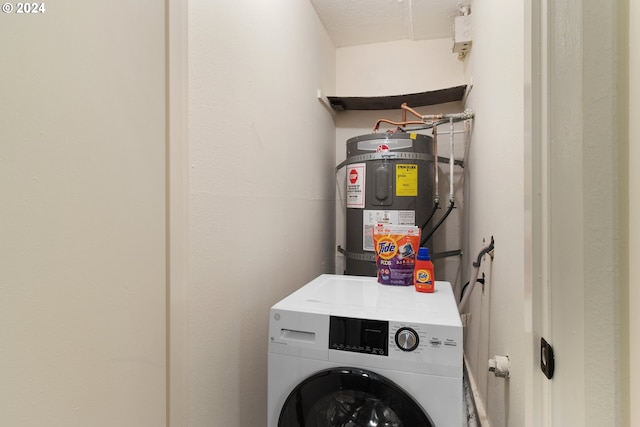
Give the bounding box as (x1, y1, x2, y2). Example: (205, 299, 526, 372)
(273, 274, 462, 327)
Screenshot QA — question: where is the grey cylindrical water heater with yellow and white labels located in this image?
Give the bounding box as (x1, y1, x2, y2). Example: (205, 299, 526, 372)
(341, 132, 434, 276)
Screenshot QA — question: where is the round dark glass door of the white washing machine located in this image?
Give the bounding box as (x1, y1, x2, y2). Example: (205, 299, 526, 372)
(278, 368, 434, 427)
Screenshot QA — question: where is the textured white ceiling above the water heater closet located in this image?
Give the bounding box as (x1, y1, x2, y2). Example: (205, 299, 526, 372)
(310, 0, 469, 47)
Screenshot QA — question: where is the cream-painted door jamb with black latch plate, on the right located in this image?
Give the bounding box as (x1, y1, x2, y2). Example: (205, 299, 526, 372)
(527, 0, 628, 426)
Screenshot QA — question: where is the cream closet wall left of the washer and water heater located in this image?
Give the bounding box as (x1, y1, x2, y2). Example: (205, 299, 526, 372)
(186, 0, 335, 427)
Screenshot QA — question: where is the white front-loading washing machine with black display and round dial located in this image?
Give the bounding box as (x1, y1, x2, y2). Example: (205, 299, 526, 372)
(267, 275, 463, 427)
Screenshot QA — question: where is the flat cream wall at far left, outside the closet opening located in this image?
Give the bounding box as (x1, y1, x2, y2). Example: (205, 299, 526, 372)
(0, 1, 166, 427)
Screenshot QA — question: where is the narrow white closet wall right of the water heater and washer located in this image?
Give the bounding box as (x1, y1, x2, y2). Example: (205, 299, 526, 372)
(465, 1, 530, 426)
